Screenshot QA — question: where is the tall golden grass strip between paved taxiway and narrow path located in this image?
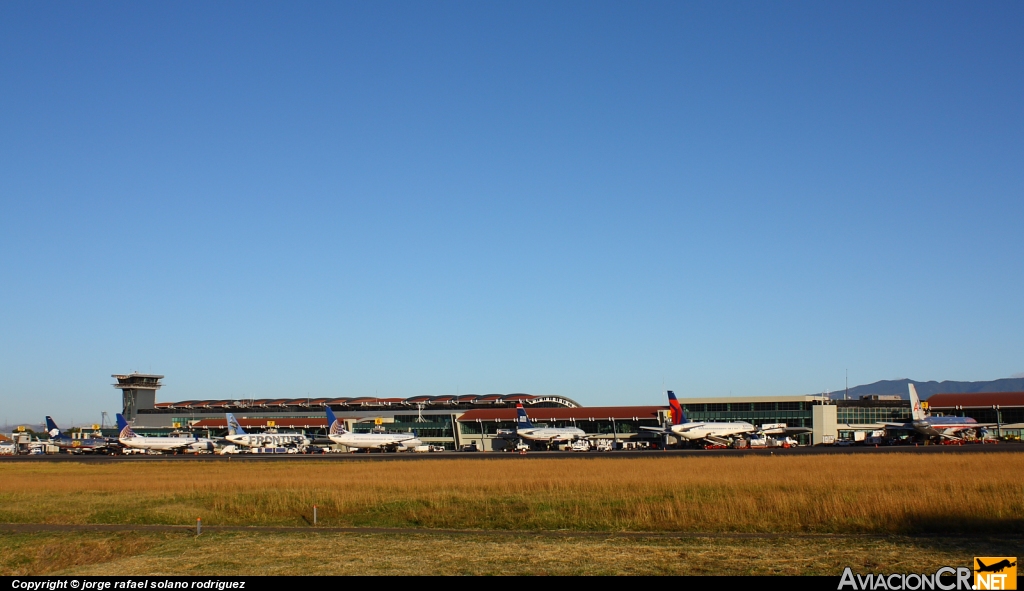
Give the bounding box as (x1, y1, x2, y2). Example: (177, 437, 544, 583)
(0, 454, 1024, 534)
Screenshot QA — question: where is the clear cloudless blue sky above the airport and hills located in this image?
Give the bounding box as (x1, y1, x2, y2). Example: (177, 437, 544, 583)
(0, 1, 1024, 422)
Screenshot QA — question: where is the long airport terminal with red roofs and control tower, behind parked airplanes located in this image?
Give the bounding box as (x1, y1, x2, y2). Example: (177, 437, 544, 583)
(114, 374, 1024, 451)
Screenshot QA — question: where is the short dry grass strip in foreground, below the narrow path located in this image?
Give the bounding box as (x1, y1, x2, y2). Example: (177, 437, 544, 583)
(0, 532, 1020, 576)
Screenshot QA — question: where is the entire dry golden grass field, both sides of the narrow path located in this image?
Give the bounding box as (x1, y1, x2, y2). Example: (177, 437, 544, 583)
(0, 454, 1024, 576)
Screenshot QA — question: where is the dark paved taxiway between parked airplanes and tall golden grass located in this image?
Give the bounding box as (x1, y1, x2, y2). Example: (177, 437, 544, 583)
(0, 444, 1024, 465)
